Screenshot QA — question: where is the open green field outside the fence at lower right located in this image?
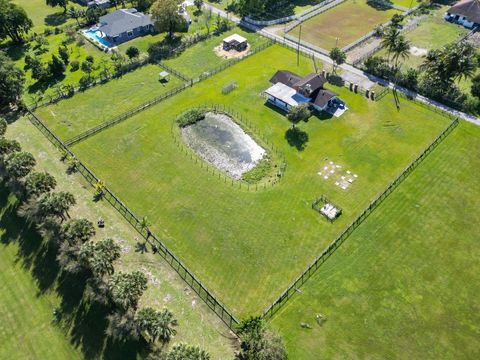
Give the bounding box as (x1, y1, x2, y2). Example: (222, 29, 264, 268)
(273, 123, 480, 360)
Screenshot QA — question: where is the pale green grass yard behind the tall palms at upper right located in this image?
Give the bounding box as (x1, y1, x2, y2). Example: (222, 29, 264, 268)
(375, 6, 468, 68)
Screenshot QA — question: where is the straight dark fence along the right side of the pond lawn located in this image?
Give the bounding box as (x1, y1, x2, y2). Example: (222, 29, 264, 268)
(263, 119, 459, 319)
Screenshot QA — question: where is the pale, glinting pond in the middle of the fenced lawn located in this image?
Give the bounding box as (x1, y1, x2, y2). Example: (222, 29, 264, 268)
(182, 112, 265, 179)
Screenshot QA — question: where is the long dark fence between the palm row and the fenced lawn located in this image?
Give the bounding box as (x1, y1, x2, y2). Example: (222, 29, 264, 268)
(28, 110, 239, 332)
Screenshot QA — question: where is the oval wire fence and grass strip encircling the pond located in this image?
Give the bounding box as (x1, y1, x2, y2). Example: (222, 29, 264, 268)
(171, 104, 287, 191)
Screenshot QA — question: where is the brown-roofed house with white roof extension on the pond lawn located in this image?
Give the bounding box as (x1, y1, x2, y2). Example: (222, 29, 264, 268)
(264, 70, 343, 111)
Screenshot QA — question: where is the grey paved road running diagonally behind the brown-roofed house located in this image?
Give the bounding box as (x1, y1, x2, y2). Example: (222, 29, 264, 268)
(204, 3, 480, 126)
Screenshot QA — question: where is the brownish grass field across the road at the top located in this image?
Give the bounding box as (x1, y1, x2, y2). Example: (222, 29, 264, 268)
(289, 0, 400, 51)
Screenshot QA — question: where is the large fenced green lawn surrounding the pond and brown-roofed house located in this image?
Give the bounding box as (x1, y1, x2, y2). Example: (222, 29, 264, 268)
(55, 46, 449, 316)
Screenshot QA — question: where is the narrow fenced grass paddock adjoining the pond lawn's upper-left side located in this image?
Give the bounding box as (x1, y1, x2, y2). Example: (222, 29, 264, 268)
(37, 65, 182, 140)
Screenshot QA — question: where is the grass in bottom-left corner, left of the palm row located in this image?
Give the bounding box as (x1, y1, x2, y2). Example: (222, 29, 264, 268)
(0, 190, 82, 360)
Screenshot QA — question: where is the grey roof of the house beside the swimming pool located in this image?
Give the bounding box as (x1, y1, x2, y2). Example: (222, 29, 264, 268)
(98, 9, 153, 37)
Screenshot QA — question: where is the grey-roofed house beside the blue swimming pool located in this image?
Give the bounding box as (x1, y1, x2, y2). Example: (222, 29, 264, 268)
(97, 9, 154, 45)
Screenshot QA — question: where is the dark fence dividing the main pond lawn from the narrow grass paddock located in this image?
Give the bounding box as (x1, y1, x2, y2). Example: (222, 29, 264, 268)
(65, 84, 190, 146)
